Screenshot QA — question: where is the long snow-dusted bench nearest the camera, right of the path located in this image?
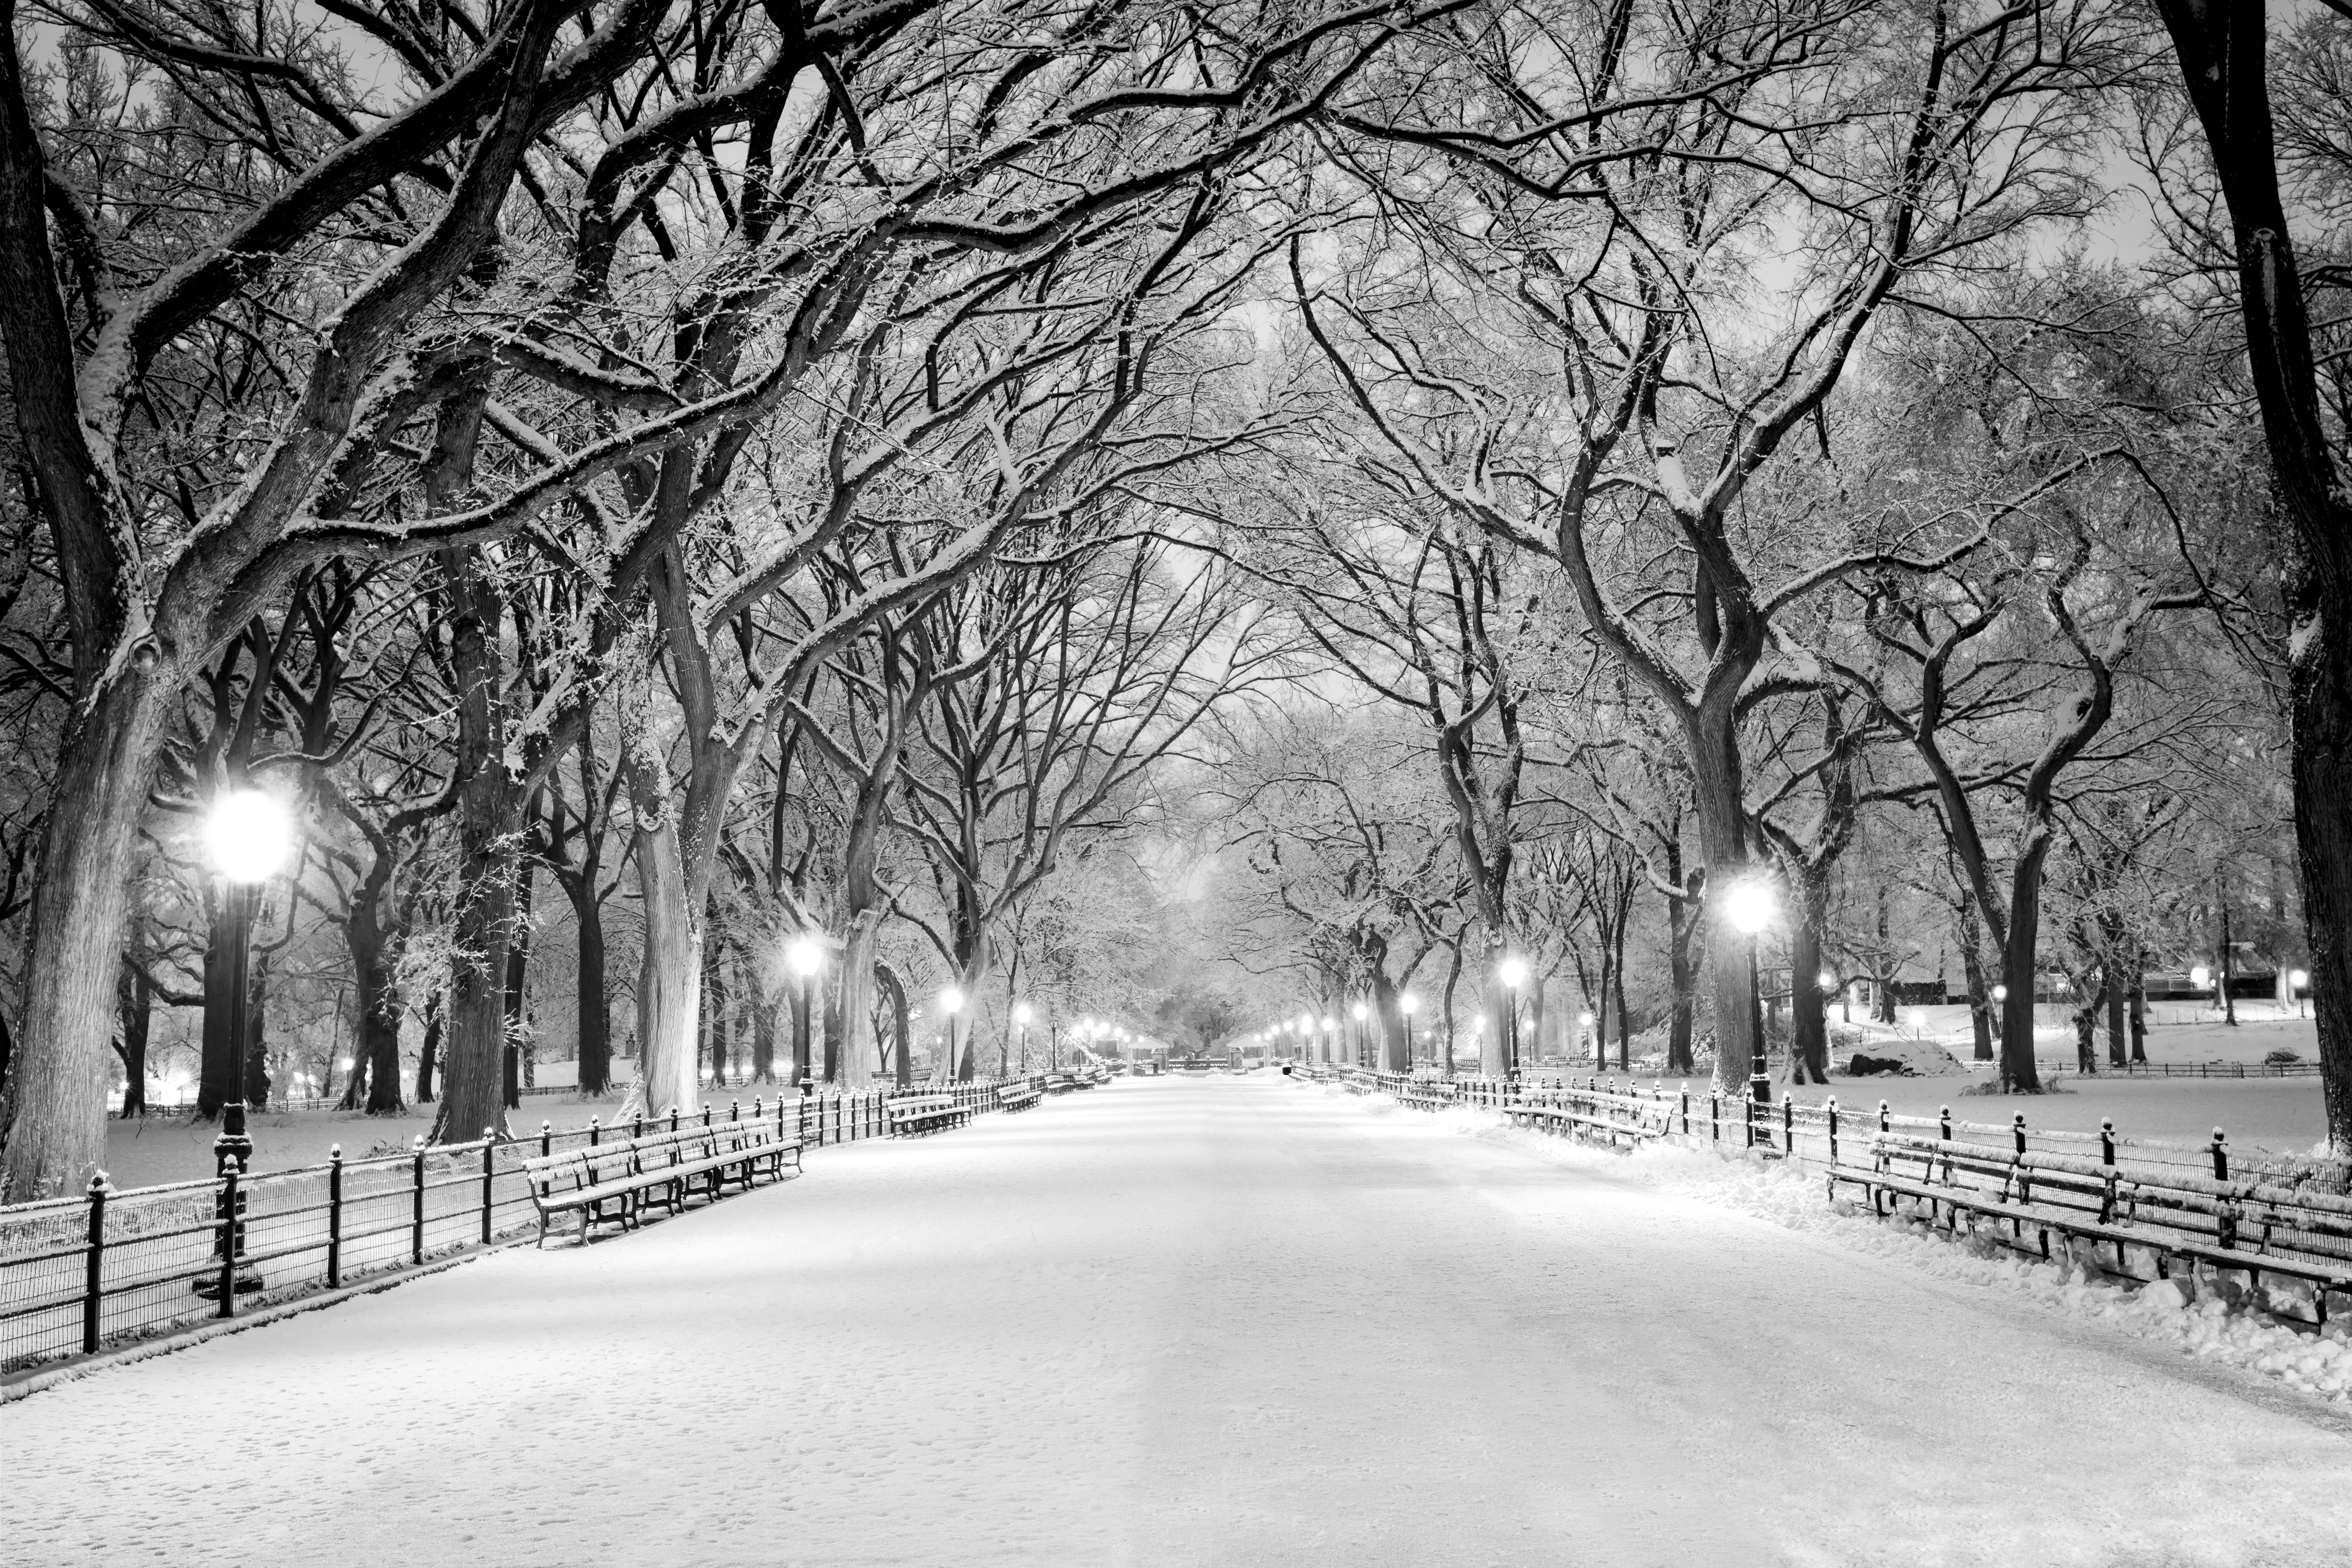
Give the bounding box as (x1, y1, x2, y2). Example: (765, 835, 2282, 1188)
(1830, 1131, 2352, 1323)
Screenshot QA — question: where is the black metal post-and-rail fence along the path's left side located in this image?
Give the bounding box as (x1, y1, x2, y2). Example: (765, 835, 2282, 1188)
(0, 1079, 1037, 1370)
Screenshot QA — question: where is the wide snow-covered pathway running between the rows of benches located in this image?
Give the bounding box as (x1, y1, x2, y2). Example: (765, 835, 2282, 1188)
(13, 1074, 2352, 1568)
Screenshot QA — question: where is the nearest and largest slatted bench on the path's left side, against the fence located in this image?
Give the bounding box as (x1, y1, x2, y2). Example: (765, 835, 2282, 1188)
(522, 1119, 800, 1246)
